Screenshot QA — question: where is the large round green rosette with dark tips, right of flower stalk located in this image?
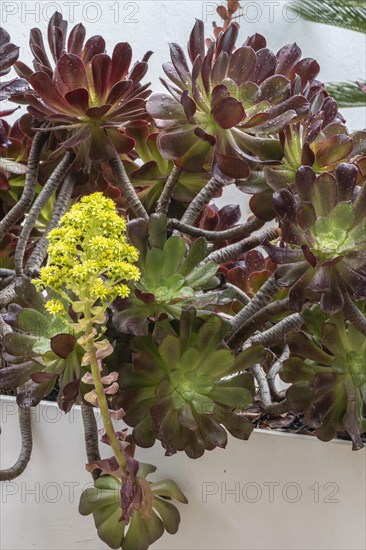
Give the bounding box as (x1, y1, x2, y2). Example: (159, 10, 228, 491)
(115, 308, 264, 458)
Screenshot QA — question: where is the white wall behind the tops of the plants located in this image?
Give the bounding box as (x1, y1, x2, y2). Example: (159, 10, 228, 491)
(0, 0, 366, 215)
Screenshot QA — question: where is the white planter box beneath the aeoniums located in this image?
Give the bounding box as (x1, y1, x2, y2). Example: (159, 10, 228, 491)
(0, 397, 366, 550)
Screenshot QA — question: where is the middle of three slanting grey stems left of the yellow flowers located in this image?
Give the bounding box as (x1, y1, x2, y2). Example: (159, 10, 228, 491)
(14, 152, 75, 275)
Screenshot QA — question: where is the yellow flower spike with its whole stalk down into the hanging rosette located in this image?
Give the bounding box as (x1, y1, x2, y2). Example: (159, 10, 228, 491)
(33, 193, 184, 550)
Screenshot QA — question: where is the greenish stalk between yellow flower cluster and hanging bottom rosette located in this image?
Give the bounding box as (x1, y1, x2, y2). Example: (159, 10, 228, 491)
(87, 338, 126, 470)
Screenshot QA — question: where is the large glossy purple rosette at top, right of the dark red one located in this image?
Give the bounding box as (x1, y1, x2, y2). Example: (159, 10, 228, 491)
(147, 21, 319, 179)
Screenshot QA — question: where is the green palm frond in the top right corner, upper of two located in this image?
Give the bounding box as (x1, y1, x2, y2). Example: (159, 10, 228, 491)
(290, 0, 366, 33)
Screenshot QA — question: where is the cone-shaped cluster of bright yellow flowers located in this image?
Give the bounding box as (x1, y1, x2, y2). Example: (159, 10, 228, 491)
(33, 193, 140, 314)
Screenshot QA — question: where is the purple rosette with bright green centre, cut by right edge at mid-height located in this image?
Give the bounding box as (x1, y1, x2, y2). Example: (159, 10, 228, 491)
(265, 163, 366, 315)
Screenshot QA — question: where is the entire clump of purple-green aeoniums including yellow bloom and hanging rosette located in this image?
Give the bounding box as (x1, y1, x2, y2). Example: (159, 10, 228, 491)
(0, 1, 366, 550)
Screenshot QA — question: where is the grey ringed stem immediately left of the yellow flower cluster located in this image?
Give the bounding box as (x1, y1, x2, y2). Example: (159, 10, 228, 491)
(25, 173, 76, 275)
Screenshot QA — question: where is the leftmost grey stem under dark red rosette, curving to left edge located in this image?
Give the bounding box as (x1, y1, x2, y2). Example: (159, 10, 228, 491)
(0, 132, 47, 239)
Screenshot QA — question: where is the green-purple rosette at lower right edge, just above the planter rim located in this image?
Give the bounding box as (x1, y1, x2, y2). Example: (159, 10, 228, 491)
(280, 303, 366, 450)
